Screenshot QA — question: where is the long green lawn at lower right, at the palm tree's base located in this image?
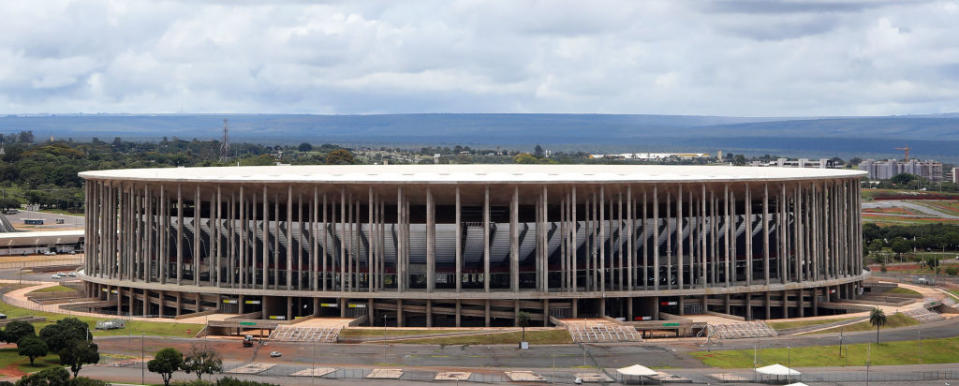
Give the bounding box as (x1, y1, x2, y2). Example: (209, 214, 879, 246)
(690, 337, 959, 368)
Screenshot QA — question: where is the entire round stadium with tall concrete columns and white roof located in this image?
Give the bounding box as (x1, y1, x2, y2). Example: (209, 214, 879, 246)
(80, 165, 866, 326)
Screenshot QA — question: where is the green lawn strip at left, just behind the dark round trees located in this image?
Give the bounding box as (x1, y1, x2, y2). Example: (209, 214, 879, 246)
(0, 302, 203, 338)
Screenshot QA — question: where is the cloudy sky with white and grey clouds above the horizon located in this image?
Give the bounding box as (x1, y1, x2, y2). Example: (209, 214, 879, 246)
(0, 0, 959, 116)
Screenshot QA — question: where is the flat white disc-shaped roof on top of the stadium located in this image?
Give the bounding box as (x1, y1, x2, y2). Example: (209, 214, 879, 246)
(80, 164, 865, 184)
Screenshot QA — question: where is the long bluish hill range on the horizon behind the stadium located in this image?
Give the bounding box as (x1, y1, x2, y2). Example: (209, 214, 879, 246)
(0, 114, 959, 161)
